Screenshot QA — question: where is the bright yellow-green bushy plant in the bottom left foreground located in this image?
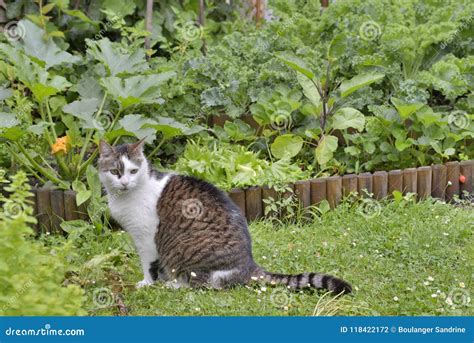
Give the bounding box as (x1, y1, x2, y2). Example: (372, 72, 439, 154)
(0, 169, 85, 316)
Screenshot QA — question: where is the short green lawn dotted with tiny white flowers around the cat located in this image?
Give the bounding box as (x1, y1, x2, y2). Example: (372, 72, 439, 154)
(61, 201, 474, 316)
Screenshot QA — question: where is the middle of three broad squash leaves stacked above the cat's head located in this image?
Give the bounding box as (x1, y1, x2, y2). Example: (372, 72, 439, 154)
(102, 72, 176, 108)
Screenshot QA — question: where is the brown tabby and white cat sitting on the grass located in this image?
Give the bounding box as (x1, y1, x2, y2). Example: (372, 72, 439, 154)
(99, 140, 352, 294)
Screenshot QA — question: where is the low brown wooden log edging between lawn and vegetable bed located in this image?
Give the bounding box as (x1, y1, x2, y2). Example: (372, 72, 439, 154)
(30, 160, 474, 233)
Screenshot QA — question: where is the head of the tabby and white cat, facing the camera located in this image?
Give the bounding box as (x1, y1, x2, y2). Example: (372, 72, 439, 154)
(99, 139, 149, 193)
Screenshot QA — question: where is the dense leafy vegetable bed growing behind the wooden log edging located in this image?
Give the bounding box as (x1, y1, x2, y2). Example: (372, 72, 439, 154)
(0, 0, 474, 198)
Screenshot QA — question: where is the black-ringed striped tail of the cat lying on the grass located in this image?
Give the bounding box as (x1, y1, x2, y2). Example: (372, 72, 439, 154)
(252, 268, 352, 294)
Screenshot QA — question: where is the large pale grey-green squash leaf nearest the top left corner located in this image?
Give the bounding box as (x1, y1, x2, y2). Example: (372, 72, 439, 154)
(14, 19, 80, 69)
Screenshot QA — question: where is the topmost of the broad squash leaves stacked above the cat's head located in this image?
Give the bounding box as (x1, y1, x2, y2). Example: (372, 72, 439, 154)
(86, 38, 148, 76)
